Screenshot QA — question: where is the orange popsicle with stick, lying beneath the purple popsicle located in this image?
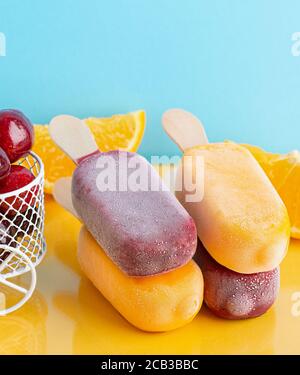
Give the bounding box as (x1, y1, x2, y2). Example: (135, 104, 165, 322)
(54, 178, 203, 332)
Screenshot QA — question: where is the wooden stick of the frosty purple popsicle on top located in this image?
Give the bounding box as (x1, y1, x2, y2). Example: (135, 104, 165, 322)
(49, 115, 100, 164)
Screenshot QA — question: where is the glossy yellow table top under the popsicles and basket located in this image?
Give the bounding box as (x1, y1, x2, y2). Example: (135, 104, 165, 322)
(0, 197, 300, 354)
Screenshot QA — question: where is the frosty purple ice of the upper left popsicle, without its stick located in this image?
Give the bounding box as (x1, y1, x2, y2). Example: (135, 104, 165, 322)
(72, 151, 197, 276)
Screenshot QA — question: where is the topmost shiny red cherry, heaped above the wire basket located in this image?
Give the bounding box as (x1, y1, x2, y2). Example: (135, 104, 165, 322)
(0, 109, 34, 163)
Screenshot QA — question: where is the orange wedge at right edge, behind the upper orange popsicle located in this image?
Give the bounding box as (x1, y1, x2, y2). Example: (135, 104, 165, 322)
(244, 145, 300, 239)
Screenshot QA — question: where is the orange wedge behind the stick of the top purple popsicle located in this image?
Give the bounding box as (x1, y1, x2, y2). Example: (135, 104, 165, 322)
(33, 111, 146, 194)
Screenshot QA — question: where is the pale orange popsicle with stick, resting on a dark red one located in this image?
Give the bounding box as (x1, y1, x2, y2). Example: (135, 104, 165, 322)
(162, 109, 290, 274)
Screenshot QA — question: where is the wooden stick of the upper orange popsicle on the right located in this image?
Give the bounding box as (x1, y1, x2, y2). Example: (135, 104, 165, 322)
(162, 108, 208, 151)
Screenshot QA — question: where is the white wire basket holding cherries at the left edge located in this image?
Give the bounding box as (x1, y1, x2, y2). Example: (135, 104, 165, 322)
(0, 152, 46, 316)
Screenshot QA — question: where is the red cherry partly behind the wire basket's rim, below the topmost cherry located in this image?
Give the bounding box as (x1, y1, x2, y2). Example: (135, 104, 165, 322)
(0, 165, 37, 216)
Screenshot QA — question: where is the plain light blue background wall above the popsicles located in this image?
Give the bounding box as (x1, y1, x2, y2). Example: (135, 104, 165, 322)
(0, 0, 300, 156)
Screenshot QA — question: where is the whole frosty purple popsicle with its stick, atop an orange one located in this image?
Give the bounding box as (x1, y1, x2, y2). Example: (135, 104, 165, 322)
(49, 116, 197, 276)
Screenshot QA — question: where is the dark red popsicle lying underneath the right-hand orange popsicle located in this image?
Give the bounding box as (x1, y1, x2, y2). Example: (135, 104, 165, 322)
(194, 241, 280, 320)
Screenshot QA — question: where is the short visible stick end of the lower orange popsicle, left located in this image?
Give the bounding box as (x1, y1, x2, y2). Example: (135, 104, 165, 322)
(53, 177, 81, 221)
